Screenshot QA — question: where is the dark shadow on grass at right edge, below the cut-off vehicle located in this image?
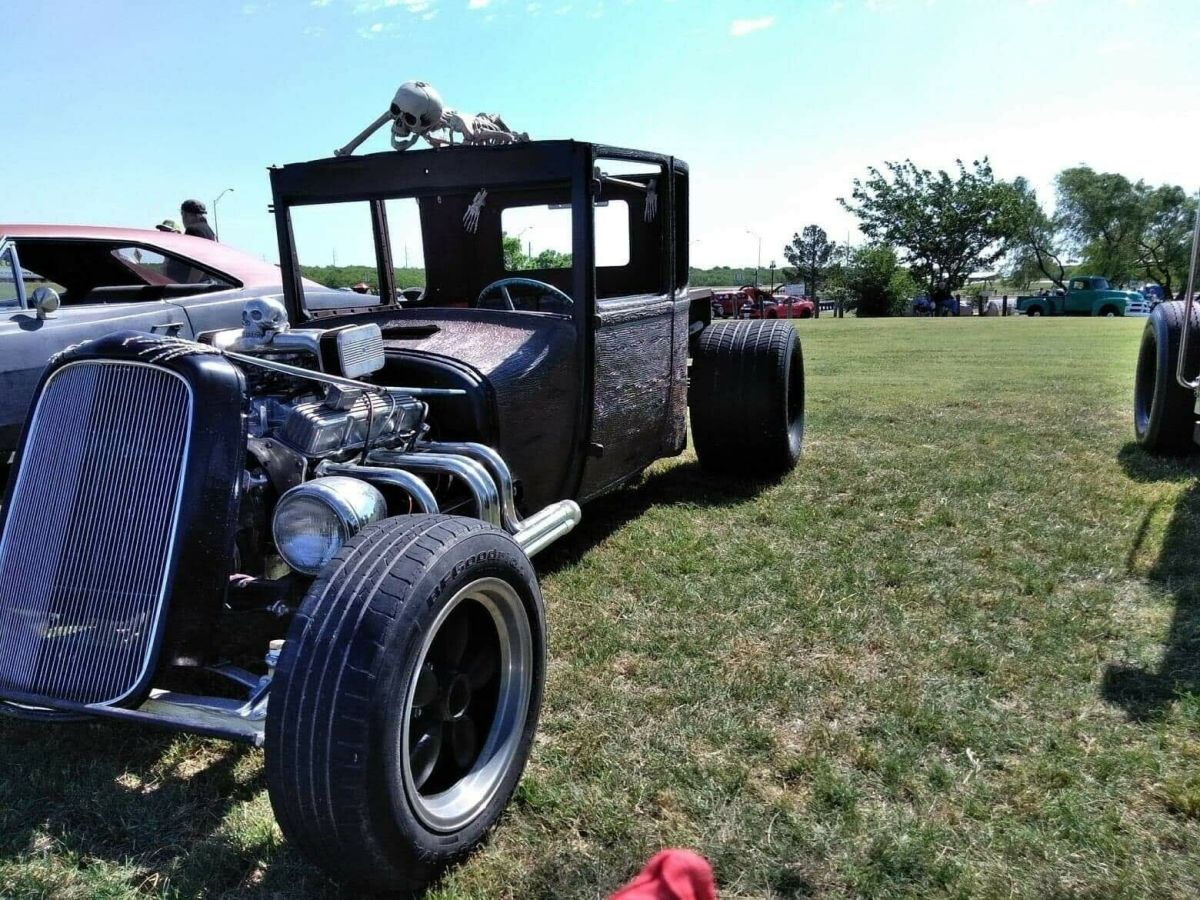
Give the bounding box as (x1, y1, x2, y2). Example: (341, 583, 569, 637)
(1100, 472, 1200, 721)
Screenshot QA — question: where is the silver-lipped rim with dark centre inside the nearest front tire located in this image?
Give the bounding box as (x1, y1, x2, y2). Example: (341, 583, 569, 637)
(397, 578, 534, 832)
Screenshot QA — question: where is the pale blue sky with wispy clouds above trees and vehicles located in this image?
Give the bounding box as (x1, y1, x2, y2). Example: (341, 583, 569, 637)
(0, 0, 1200, 265)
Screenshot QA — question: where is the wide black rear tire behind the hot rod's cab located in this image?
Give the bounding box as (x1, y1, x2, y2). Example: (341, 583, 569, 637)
(688, 320, 804, 476)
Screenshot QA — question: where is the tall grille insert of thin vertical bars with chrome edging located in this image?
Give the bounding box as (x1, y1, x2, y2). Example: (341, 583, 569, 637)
(0, 361, 192, 703)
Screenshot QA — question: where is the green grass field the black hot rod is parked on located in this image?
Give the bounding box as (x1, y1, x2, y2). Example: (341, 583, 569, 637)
(0, 318, 1200, 898)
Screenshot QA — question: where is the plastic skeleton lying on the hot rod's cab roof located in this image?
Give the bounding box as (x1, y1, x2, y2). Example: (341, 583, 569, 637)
(334, 82, 529, 156)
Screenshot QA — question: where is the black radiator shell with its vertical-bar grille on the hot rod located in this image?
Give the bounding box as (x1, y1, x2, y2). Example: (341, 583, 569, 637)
(0, 332, 246, 707)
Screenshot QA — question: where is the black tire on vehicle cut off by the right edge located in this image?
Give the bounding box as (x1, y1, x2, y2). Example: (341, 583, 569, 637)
(1133, 300, 1200, 454)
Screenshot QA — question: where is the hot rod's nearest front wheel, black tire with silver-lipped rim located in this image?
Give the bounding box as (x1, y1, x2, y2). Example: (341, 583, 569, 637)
(266, 516, 546, 893)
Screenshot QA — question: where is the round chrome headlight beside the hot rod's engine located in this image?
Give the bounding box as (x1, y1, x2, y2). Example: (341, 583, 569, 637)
(271, 475, 388, 575)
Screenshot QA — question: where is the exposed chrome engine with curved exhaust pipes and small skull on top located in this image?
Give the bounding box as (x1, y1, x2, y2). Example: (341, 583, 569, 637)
(212, 298, 580, 574)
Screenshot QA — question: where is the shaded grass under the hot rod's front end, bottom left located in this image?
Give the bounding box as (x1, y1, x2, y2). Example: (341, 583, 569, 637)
(0, 719, 336, 898)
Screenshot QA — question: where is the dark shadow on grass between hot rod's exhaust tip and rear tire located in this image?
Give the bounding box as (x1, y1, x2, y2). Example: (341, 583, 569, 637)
(538, 460, 778, 575)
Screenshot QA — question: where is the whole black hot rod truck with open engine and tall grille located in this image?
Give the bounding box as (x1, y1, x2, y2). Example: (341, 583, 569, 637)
(0, 133, 804, 890)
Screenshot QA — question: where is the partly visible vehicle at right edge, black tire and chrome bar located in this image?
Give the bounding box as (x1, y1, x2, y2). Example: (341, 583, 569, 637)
(1133, 204, 1200, 455)
